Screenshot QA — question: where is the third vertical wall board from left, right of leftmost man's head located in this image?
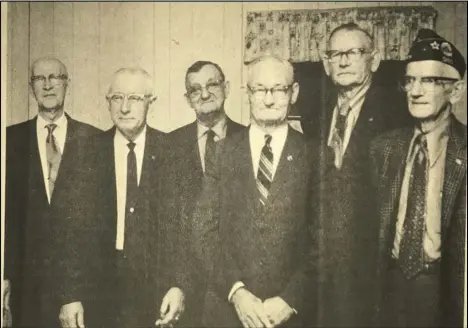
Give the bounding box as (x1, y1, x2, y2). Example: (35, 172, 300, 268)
(53, 2, 74, 115)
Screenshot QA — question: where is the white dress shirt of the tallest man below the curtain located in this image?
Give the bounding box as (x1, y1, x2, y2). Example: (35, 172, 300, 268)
(328, 80, 372, 157)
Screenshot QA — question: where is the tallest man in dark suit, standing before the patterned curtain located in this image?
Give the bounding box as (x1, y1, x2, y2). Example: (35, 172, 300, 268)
(311, 23, 409, 327)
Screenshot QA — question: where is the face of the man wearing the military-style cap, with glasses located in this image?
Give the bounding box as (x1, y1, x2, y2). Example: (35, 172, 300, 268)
(405, 60, 462, 120)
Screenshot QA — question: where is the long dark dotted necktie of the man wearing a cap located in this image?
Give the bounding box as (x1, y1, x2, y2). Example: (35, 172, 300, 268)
(399, 135, 428, 279)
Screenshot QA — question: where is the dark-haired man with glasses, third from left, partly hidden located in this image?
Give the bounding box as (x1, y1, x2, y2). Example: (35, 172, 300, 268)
(169, 61, 244, 327)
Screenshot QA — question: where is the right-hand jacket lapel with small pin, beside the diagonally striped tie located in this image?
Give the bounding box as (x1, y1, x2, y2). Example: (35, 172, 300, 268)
(266, 128, 301, 206)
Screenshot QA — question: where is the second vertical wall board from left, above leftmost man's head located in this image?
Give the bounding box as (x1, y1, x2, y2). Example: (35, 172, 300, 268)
(29, 2, 54, 118)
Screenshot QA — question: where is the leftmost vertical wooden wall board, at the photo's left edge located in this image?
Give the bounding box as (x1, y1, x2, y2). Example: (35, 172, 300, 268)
(7, 2, 29, 125)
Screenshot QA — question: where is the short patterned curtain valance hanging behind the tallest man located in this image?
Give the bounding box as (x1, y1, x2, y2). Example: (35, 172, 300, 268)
(244, 7, 437, 63)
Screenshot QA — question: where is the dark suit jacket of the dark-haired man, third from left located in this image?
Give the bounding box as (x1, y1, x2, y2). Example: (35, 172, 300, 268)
(168, 118, 245, 327)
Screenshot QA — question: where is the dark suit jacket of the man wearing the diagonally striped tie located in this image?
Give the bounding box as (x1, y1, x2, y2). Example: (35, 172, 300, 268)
(193, 128, 316, 327)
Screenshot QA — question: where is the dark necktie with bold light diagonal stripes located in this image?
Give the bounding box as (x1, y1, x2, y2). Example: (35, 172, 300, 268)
(256, 134, 273, 205)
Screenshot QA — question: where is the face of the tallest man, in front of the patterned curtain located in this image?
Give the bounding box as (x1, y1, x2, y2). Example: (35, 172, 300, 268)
(324, 30, 380, 88)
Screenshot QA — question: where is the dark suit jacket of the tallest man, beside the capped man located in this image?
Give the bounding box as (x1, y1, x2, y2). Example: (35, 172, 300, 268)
(310, 81, 411, 327)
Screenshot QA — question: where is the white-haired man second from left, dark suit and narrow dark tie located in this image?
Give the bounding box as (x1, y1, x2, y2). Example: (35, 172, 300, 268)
(53, 68, 185, 328)
